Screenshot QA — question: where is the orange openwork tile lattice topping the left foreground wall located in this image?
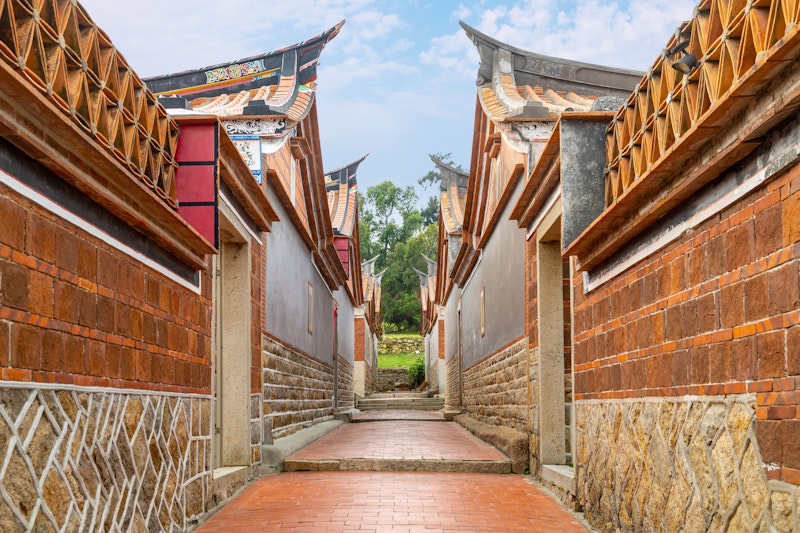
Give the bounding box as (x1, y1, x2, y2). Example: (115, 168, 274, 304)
(0, 0, 178, 209)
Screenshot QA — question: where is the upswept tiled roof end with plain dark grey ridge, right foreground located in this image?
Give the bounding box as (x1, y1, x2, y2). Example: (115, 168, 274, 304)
(461, 22, 641, 120)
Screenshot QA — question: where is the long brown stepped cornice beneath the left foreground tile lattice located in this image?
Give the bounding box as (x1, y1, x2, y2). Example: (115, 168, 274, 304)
(0, 61, 217, 270)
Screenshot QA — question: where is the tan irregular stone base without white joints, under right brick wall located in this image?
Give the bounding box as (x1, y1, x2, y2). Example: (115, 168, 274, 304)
(575, 394, 800, 532)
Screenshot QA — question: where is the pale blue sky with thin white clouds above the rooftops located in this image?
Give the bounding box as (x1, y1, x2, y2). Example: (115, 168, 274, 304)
(81, 0, 695, 201)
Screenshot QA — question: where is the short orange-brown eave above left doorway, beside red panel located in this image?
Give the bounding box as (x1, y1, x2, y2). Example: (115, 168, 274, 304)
(219, 125, 279, 231)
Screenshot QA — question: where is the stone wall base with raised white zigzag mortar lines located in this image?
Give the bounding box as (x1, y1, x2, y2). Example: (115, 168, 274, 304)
(0, 387, 213, 531)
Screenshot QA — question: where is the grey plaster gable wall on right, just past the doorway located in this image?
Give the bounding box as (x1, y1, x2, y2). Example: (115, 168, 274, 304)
(461, 180, 525, 369)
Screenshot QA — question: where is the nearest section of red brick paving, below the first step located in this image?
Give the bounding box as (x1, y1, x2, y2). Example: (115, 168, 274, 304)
(196, 472, 586, 533)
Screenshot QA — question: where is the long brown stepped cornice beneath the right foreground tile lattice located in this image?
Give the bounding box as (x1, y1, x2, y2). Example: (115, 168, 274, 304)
(563, 34, 800, 270)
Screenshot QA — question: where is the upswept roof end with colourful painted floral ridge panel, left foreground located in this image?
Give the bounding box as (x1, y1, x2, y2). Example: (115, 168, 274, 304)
(145, 20, 345, 122)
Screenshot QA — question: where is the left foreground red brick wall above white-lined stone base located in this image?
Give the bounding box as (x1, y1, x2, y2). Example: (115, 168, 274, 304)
(0, 186, 211, 393)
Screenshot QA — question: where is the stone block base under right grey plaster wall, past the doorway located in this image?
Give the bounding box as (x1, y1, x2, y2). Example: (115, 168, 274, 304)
(464, 337, 528, 432)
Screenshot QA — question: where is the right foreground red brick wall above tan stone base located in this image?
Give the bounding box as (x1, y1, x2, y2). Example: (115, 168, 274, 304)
(574, 165, 800, 483)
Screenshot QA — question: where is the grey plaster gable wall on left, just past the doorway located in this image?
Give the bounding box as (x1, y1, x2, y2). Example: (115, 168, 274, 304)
(265, 184, 334, 364)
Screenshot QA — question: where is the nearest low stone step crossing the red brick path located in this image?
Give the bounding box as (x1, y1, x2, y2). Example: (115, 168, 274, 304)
(283, 459, 511, 474)
